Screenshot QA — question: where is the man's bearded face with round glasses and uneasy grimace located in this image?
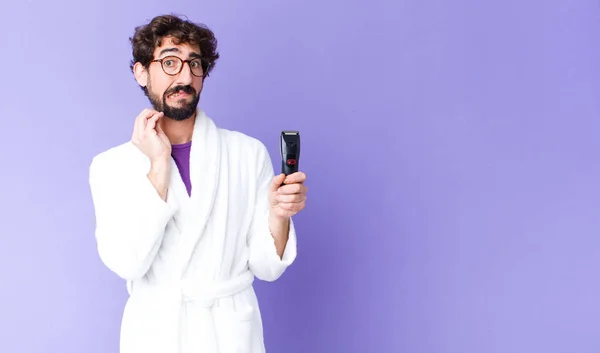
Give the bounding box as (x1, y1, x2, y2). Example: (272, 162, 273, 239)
(140, 38, 203, 121)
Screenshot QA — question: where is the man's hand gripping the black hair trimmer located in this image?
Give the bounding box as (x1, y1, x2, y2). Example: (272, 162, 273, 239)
(269, 172, 308, 219)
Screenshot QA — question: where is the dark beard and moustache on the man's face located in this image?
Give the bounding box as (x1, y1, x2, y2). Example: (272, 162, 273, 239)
(146, 84, 200, 121)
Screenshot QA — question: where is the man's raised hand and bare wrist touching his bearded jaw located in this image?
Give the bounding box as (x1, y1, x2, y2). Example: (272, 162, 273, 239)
(131, 109, 171, 201)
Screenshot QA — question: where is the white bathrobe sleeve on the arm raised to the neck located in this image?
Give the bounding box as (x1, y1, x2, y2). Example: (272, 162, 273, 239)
(89, 151, 175, 280)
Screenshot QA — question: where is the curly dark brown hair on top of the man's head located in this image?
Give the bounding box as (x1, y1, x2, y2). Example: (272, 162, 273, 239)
(129, 15, 219, 77)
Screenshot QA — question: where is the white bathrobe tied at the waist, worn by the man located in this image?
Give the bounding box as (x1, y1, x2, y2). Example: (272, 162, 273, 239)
(90, 110, 296, 353)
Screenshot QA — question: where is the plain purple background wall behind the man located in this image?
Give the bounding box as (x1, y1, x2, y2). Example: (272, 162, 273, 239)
(0, 0, 600, 353)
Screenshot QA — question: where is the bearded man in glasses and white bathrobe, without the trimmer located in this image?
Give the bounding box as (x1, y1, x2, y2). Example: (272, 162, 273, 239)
(90, 16, 307, 353)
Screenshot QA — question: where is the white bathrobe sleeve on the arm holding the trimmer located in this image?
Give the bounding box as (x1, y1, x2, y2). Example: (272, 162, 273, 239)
(249, 142, 297, 282)
